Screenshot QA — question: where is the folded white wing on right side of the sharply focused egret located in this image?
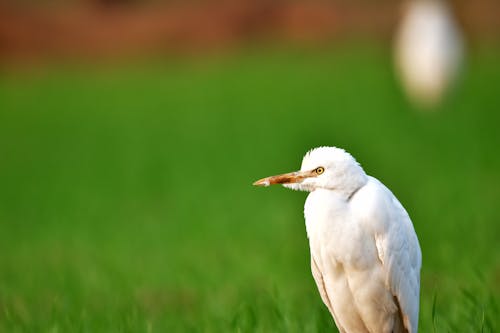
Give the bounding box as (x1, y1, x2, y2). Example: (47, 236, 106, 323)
(362, 179, 422, 333)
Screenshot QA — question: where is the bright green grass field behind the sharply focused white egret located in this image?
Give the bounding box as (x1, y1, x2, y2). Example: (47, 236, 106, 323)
(0, 45, 500, 332)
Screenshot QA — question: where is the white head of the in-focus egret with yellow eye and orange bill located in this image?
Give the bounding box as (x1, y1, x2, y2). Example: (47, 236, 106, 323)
(254, 147, 367, 196)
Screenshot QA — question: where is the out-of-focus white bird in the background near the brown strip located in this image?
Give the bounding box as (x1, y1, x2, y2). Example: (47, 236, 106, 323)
(394, 0, 464, 108)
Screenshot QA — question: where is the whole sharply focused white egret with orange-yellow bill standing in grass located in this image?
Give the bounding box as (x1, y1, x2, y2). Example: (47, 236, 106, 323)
(254, 147, 422, 333)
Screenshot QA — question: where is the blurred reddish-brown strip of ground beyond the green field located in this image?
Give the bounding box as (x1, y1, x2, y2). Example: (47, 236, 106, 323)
(0, 0, 500, 62)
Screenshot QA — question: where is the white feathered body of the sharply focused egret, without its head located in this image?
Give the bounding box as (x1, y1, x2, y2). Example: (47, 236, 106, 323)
(304, 177, 420, 332)
